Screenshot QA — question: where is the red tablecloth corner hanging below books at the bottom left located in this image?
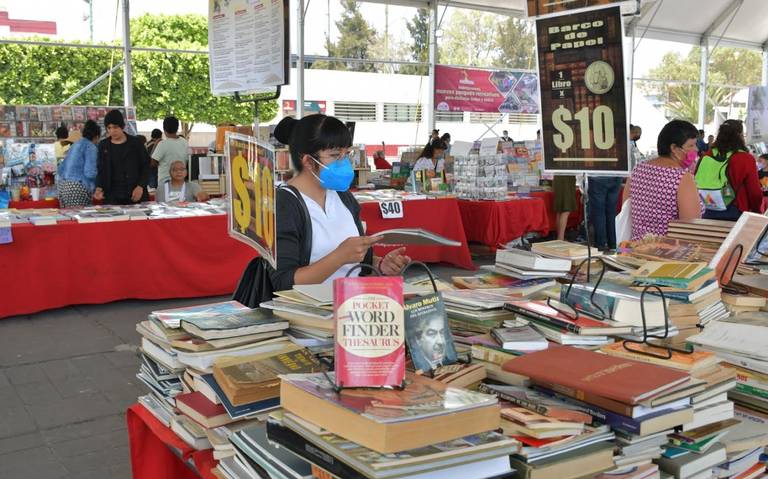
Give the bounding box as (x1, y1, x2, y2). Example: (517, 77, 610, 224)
(125, 404, 216, 479)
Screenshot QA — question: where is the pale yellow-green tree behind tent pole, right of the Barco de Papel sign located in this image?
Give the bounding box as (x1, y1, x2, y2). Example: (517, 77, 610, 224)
(640, 47, 762, 123)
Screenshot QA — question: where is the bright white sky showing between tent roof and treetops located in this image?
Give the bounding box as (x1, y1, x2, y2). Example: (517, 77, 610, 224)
(0, 0, 691, 77)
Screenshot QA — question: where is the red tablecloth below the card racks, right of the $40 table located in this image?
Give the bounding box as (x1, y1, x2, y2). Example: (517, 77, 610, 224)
(459, 198, 550, 248)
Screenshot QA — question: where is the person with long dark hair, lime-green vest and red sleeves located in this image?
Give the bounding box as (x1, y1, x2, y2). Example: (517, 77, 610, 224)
(696, 120, 763, 221)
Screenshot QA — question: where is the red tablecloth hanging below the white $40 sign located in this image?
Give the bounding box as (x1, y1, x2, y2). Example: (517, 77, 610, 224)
(360, 198, 476, 270)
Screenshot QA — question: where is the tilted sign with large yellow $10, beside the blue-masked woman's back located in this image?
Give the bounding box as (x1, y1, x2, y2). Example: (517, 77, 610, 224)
(224, 132, 277, 268)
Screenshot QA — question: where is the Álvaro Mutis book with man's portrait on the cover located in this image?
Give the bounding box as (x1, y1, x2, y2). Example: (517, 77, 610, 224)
(403, 293, 456, 372)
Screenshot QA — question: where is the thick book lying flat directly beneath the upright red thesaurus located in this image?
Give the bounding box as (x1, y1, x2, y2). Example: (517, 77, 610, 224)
(280, 373, 500, 453)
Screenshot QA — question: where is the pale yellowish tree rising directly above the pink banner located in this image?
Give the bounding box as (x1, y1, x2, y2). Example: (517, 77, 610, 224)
(439, 9, 499, 67)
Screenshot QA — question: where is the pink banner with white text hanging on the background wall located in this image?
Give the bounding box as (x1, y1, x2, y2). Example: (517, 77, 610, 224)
(435, 65, 539, 114)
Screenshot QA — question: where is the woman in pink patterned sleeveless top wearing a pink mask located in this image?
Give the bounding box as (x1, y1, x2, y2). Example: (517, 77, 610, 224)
(624, 120, 704, 240)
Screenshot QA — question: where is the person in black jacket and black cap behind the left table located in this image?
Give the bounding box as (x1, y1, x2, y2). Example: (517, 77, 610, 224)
(93, 110, 149, 205)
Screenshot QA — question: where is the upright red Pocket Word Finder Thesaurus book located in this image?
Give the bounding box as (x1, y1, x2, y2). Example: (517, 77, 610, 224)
(333, 276, 405, 387)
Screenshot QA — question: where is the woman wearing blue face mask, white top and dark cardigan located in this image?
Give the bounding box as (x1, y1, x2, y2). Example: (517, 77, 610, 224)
(271, 115, 410, 291)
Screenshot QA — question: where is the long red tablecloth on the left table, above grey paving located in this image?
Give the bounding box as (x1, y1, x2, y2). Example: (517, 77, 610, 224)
(0, 215, 256, 318)
